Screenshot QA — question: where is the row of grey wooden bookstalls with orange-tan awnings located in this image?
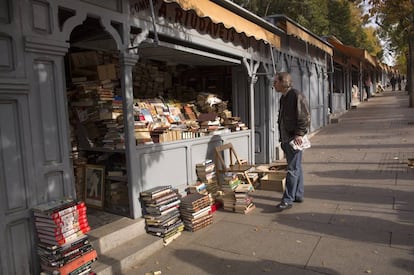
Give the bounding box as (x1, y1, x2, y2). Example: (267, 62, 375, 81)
(0, 0, 392, 274)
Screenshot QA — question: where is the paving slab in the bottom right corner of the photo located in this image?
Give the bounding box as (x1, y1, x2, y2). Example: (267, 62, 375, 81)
(308, 237, 414, 275)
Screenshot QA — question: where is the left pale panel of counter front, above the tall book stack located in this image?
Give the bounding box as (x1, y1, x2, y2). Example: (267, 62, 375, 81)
(140, 148, 187, 190)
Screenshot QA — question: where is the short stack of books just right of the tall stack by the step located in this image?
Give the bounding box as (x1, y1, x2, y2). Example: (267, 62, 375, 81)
(180, 193, 213, 232)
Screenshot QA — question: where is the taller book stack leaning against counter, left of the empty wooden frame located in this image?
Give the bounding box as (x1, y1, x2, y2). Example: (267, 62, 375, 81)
(196, 159, 220, 203)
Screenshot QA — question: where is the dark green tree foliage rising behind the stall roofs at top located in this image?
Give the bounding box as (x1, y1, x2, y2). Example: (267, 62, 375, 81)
(230, 0, 382, 57)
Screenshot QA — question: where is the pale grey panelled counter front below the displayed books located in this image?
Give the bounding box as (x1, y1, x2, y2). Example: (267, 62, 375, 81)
(136, 130, 252, 193)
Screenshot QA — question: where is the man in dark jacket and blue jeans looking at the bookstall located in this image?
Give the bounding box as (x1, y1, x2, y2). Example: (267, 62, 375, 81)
(273, 72, 310, 211)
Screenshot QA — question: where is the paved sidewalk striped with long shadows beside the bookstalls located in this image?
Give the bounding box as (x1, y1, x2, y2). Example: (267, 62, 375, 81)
(128, 91, 414, 275)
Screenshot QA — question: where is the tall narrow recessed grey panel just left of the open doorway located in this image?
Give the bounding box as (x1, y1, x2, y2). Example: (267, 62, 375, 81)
(34, 60, 61, 163)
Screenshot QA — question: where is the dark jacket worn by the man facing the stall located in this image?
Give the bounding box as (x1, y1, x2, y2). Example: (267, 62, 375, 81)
(278, 89, 310, 142)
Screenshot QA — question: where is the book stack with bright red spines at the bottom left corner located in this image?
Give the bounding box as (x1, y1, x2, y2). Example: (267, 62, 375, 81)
(32, 198, 98, 275)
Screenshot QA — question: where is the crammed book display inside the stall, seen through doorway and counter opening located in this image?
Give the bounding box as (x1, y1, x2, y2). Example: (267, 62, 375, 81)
(67, 49, 248, 216)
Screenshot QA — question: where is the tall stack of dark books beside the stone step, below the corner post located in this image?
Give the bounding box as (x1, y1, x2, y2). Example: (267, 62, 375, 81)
(140, 188, 184, 245)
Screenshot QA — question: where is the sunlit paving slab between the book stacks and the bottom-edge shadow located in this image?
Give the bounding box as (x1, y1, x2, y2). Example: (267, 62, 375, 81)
(194, 221, 319, 266)
